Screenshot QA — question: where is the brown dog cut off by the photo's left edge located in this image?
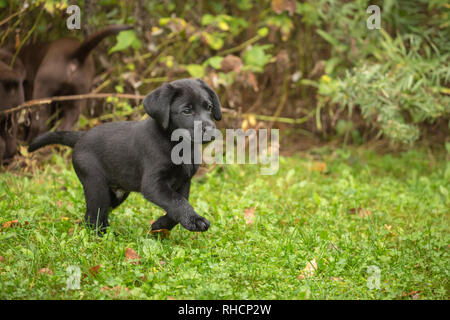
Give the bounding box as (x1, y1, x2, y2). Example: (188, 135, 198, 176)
(0, 49, 25, 163)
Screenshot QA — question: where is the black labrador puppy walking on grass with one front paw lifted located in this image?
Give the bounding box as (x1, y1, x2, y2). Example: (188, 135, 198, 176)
(29, 79, 222, 231)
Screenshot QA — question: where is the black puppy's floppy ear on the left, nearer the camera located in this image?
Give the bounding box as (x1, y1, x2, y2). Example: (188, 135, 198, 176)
(143, 83, 175, 130)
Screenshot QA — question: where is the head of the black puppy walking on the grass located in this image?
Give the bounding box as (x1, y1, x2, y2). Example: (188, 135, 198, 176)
(144, 79, 222, 143)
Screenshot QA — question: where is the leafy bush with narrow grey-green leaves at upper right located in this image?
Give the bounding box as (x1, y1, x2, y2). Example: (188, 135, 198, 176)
(312, 1, 450, 144)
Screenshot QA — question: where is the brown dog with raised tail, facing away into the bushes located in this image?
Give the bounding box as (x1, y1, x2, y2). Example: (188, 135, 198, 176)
(20, 25, 132, 142)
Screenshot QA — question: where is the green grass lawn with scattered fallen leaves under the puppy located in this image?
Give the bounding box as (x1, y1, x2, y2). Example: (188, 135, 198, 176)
(0, 148, 450, 299)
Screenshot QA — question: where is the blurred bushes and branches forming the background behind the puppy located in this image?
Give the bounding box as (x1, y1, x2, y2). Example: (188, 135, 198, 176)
(0, 0, 450, 146)
